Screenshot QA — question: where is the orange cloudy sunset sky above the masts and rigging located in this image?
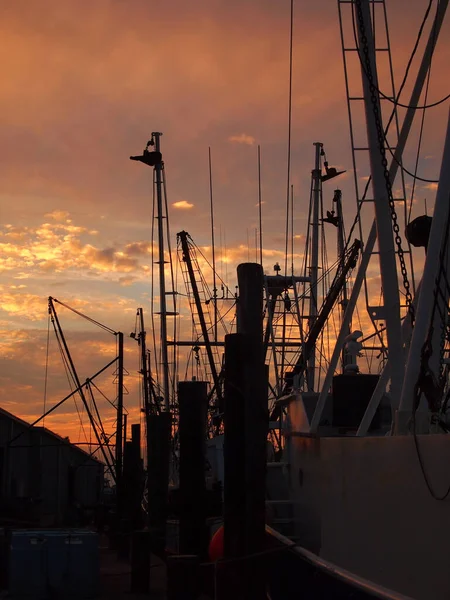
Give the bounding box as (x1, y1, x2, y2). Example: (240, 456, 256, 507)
(0, 0, 450, 441)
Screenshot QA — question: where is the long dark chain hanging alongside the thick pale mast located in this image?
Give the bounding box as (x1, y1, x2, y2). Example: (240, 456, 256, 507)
(355, 0, 415, 325)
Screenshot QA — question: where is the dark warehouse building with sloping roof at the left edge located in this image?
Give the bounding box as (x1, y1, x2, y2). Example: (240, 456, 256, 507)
(0, 408, 104, 527)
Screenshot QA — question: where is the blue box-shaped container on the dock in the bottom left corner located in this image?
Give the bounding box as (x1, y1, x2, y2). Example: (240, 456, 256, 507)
(8, 529, 99, 600)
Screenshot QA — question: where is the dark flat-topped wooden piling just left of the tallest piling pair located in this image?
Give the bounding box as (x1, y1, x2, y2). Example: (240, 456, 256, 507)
(178, 381, 208, 559)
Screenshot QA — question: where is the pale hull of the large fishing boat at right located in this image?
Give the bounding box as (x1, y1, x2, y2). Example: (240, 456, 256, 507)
(286, 398, 450, 600)
